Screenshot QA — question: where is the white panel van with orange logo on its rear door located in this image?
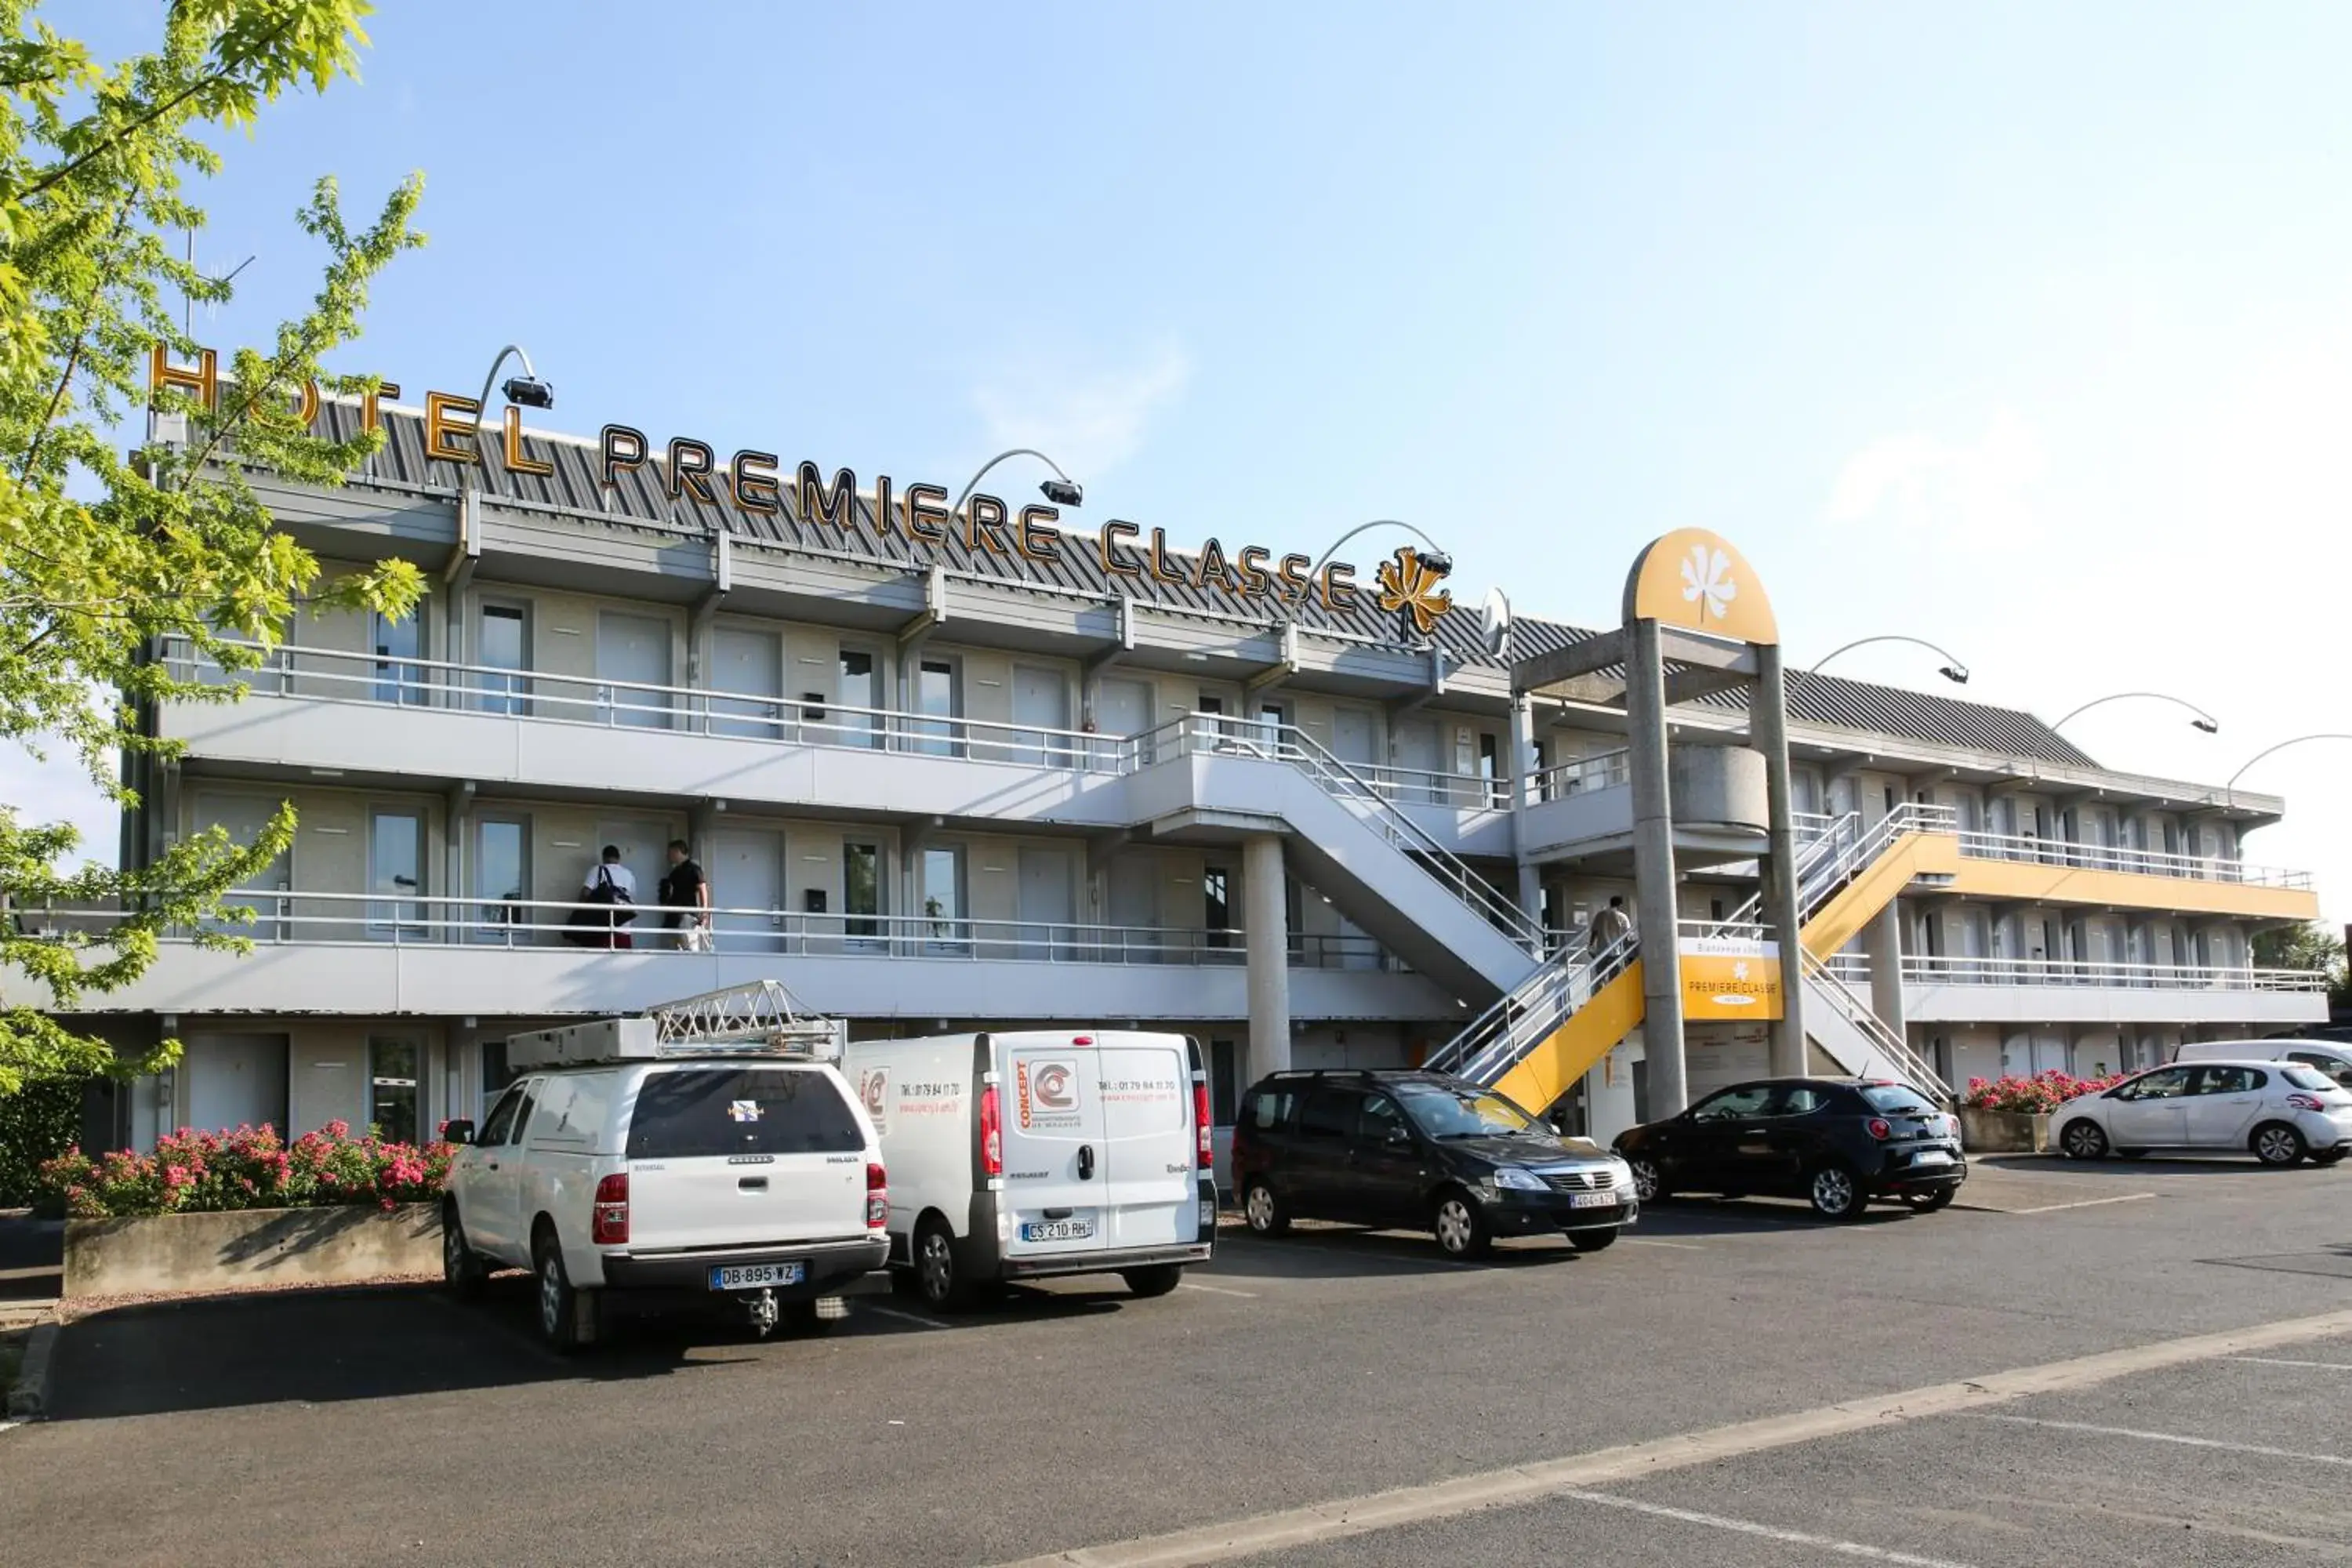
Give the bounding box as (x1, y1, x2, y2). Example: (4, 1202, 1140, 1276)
(844, 1029, 1216, 1309)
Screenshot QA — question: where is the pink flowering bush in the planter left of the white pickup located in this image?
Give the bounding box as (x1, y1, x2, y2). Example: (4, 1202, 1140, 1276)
(40, 1121, 456, 1220)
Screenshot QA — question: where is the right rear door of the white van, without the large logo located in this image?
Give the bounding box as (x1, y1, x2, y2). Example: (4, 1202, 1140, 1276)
(1096, 1034, 1200, 1248)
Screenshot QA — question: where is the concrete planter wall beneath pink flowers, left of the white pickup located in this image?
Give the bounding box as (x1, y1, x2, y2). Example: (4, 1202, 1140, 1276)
(66, 1203, 440, 1298)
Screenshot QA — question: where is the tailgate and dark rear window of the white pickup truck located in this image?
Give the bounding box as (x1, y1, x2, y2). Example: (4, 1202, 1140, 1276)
(626, 1062, 866, 1253)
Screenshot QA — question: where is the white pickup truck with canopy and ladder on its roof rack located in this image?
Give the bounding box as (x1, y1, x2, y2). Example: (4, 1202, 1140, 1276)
(442, 1018, 889, 1352)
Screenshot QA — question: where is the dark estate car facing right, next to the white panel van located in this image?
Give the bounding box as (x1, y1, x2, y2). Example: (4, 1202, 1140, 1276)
(1232, 1069, 1639, 1258)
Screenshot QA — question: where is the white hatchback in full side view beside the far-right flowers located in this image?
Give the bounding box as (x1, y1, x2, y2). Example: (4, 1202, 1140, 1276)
(2051, 1060, 2352, 1166)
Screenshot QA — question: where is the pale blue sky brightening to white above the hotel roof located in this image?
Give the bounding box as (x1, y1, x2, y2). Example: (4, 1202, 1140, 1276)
(19, 2, 2352, 916)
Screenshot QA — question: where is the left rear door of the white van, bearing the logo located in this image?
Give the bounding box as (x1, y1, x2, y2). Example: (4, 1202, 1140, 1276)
(997, 1034, 1110, 1258)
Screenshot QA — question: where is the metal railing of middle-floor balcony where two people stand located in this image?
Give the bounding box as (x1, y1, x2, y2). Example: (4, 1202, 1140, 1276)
(9, 888, 1404, 971)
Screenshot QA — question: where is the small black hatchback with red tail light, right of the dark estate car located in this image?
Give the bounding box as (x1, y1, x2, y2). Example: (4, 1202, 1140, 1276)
(1616, 1079, 1969, 1220)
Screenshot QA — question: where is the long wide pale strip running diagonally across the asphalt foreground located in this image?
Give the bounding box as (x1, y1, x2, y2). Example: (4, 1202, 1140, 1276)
(988, 1312, 2352, 1568)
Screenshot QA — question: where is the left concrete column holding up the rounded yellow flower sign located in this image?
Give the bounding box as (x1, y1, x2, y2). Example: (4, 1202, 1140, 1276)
(1625, 621, 1691, 1119)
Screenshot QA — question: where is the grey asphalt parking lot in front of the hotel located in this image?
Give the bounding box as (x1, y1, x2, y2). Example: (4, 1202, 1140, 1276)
(0, 1161, 2352, 1568)
